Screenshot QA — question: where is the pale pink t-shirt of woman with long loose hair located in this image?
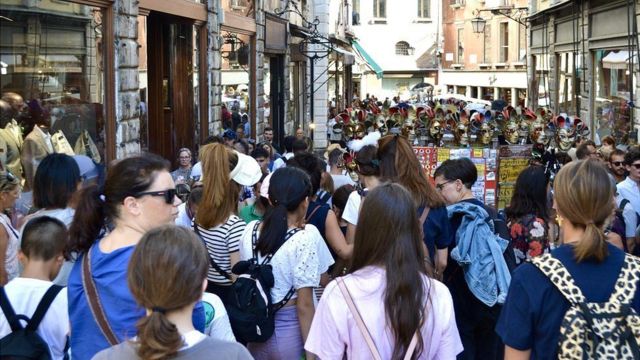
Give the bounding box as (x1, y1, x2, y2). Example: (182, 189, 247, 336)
(305, 266, 462, 360)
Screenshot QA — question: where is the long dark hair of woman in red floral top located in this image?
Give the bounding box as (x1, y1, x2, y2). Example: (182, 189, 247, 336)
(505, 166, 549, 222)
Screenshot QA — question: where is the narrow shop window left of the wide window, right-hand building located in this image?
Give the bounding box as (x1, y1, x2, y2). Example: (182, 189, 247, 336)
(557, 53, 582, 116)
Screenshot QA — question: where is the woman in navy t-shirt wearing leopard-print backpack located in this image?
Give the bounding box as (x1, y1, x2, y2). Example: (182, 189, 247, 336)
(496, 160, 640, 359)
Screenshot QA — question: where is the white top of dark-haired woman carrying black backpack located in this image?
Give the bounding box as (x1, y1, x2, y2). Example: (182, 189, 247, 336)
(240, 221, 333, 303)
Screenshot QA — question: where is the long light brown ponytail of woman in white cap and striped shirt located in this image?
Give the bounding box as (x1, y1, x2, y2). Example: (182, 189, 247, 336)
(196, 144, 240, 229)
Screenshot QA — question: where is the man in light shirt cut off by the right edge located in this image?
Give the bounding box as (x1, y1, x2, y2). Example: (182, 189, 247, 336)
(617, 145, 640, 255)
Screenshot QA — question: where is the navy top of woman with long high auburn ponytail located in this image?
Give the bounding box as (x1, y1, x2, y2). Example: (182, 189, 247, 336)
(418, 206, 455, 262)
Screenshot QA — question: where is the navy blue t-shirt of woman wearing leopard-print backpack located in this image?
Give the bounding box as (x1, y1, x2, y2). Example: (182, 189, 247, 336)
(496, 244, 640, 359)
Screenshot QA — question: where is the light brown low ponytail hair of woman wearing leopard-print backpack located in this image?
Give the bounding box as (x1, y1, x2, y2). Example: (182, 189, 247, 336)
(554, 160, 615, 262)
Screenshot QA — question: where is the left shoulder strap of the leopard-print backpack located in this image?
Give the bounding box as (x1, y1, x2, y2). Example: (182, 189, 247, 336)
(531, 254, 586, 305)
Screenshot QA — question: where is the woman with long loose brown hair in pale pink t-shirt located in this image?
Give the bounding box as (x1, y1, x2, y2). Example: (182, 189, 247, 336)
(305, 183, 462, 360)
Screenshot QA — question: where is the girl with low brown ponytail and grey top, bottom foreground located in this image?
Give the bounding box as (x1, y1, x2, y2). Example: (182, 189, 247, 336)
(94, 225, 251, 360)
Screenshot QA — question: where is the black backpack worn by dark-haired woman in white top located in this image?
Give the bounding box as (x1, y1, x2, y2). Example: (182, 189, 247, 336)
(225, 222, 301, 343)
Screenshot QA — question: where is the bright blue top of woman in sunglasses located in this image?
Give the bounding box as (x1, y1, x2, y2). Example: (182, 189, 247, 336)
(67, 242, 205, 359)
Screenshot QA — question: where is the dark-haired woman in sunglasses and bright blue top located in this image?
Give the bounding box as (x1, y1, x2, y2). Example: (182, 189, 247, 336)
(68, 154, 204, 359)
